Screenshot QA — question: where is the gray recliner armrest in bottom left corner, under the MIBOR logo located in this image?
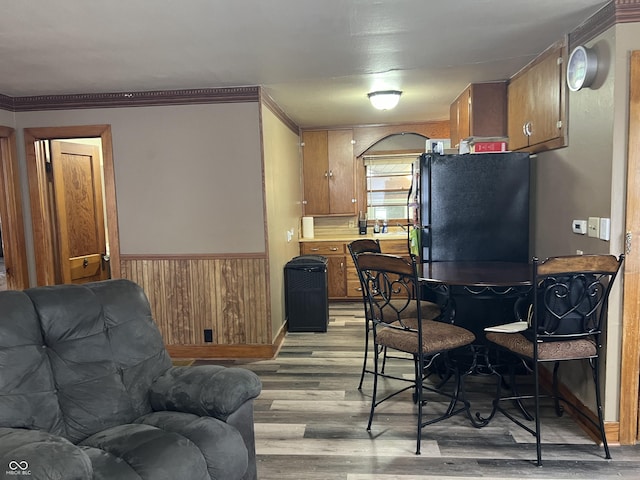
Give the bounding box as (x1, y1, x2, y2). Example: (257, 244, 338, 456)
(0, 428, 93, 480)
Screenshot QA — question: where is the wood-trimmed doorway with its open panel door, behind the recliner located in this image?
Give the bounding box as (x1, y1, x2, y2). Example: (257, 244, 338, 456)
(24, 125, 120, 285)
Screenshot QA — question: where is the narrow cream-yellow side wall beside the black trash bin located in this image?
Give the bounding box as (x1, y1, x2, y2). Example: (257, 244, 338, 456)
(261, 105, 302, 338)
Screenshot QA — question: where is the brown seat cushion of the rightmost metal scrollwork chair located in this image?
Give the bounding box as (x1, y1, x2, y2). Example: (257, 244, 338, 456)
(487, 332, 597, 361)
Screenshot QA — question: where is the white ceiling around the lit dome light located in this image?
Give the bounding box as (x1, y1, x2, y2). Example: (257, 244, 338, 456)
(0, 0, 607, 127)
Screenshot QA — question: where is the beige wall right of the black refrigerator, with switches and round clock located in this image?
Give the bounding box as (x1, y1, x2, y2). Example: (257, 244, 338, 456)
(534, 24, 640, 421)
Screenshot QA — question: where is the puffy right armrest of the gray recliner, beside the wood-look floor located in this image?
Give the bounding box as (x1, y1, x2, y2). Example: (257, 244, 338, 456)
(149, 365, 262, 421)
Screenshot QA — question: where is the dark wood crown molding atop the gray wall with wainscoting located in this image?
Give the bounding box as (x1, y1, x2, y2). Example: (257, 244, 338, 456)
(0, 86, 260, 112)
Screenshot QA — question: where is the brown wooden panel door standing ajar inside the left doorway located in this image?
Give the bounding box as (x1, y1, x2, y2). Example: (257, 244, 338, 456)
(51, 140, 109, 283)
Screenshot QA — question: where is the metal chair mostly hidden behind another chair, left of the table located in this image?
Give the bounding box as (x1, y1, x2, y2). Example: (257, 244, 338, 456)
(347, 238, 440, 390)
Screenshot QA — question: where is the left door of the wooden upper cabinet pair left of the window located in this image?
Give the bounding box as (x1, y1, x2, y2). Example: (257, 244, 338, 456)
(302, 130, 329, 215)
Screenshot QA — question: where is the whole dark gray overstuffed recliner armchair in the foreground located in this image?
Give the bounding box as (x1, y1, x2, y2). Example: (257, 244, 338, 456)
(0, 280, 261, 480)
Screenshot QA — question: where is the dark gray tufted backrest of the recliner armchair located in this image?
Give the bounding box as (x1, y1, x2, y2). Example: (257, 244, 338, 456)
(0, 280, 171, 443)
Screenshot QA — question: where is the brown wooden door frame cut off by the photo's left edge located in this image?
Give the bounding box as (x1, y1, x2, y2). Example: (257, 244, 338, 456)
(0, 126, 29, 290)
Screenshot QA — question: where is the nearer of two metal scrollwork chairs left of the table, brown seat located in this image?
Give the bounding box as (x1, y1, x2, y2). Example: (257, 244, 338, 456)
(356, 253, 475, 454)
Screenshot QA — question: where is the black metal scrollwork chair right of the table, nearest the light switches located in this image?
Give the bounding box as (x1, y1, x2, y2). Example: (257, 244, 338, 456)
(486, 255, 624, 465)
